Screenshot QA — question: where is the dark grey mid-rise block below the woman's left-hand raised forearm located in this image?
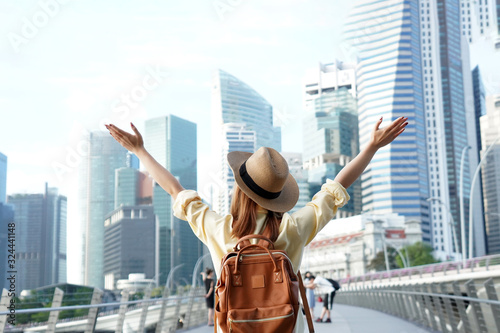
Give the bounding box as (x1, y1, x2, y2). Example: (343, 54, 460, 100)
(104, 205, 159, 290)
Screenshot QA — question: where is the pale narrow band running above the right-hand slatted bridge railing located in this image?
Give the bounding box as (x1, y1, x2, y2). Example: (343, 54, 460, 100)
(340, 254, 500, 285)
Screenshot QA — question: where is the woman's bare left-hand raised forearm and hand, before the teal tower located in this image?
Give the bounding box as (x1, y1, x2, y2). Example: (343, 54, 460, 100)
(106, 123, 184, 200)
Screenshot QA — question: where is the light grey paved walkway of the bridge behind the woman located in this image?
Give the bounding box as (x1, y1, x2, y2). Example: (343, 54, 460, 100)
(184, 304, 432, 333)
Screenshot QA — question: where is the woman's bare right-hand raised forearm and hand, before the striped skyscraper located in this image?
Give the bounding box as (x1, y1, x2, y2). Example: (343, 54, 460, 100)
(335, 117, 408, 188)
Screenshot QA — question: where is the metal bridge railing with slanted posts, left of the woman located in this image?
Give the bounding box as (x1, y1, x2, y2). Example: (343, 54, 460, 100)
(0, 287, 207, 333)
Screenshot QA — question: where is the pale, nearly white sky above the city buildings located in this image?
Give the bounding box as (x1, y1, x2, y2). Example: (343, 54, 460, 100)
(0, 0, 358, 196)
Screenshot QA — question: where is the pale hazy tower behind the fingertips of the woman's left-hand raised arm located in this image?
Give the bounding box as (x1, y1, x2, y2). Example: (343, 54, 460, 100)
(79, 131, 130, 288)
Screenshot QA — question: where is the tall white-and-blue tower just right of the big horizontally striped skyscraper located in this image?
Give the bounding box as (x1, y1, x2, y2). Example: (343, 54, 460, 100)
(420, 0, 484, 259)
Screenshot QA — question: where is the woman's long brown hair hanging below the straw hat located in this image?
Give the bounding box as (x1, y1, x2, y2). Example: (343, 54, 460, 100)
(230, 184, 283, 242)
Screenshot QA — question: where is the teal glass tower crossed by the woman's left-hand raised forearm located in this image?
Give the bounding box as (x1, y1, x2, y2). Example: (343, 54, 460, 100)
(144, 115, 203, 284)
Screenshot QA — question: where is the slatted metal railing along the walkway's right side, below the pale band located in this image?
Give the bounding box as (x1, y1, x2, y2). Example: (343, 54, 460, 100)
(335, 278, 500, 333)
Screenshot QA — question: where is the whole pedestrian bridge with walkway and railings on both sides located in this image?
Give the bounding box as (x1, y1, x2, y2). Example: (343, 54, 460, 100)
(0, 256, 500, 333)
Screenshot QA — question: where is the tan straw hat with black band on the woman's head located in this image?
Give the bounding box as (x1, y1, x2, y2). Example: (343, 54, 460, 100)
(227, 147, 299, 213)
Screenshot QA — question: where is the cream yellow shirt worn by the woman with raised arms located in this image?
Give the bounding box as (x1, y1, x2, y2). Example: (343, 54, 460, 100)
(173, 179, 350, 276)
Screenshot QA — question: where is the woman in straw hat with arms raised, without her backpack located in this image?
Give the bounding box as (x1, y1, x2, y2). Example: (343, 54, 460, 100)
(106, 117, 408, 332)
